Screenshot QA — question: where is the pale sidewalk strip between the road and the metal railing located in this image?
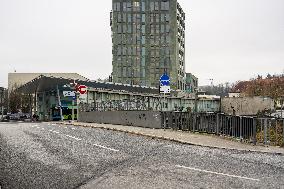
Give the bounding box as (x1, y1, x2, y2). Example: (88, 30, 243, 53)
(60, 122, 284, 155)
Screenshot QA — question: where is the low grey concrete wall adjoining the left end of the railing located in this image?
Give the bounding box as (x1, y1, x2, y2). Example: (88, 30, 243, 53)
(79, 111, 162, 128)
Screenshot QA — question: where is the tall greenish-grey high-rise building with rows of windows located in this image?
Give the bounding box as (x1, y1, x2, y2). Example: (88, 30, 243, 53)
(111, 0, 186, 90)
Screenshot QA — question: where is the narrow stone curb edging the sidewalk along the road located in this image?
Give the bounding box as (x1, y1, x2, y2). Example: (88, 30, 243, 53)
(59, 123, 284, 156)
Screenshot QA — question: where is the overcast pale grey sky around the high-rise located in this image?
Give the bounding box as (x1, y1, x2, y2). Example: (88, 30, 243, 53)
(0, 0, 284, 86)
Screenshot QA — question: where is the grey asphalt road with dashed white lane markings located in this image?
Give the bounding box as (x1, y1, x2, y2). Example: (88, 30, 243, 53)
(0, 123, 284, 189)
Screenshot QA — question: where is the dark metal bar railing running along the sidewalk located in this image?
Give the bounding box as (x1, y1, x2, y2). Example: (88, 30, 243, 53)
(161, 112, 284, 146)
